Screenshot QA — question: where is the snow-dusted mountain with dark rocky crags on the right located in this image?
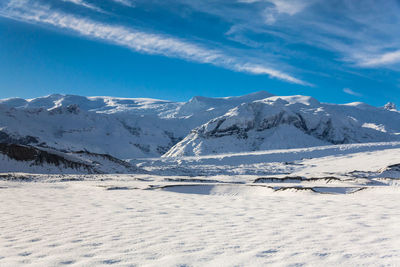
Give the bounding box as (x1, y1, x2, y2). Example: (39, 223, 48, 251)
(164, 96, 400, 157)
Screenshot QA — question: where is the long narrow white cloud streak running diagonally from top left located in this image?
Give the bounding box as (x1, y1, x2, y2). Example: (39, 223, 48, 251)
(0, 0, 310, 86)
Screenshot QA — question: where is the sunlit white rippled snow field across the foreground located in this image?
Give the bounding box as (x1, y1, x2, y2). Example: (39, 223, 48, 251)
(0, 182, 400, 266)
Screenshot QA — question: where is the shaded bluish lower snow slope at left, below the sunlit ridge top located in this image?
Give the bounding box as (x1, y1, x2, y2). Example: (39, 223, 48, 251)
(0, 105, 177, 158)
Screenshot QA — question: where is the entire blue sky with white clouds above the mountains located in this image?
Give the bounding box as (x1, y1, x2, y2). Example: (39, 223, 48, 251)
(0, 0, 400, 106)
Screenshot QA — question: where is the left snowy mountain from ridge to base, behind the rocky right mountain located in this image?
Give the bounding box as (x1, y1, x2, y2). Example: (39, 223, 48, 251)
(0, 92, 270, 158)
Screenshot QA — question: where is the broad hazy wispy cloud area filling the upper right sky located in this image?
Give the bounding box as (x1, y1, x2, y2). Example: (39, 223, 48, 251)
(182, 0, 400, 72)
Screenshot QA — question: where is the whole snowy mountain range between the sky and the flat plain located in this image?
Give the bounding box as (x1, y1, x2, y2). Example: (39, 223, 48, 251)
(0, 91, 400, 164)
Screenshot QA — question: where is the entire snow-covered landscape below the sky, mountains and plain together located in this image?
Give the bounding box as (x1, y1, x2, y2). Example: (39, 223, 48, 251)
(0, 92, 400, 266)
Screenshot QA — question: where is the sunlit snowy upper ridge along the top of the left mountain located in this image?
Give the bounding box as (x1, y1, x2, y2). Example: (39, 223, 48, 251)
(0, 91, 272, 119)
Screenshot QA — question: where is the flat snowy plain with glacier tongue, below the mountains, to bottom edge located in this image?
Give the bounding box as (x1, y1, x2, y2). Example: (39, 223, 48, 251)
(0, 142, 400, 266)
